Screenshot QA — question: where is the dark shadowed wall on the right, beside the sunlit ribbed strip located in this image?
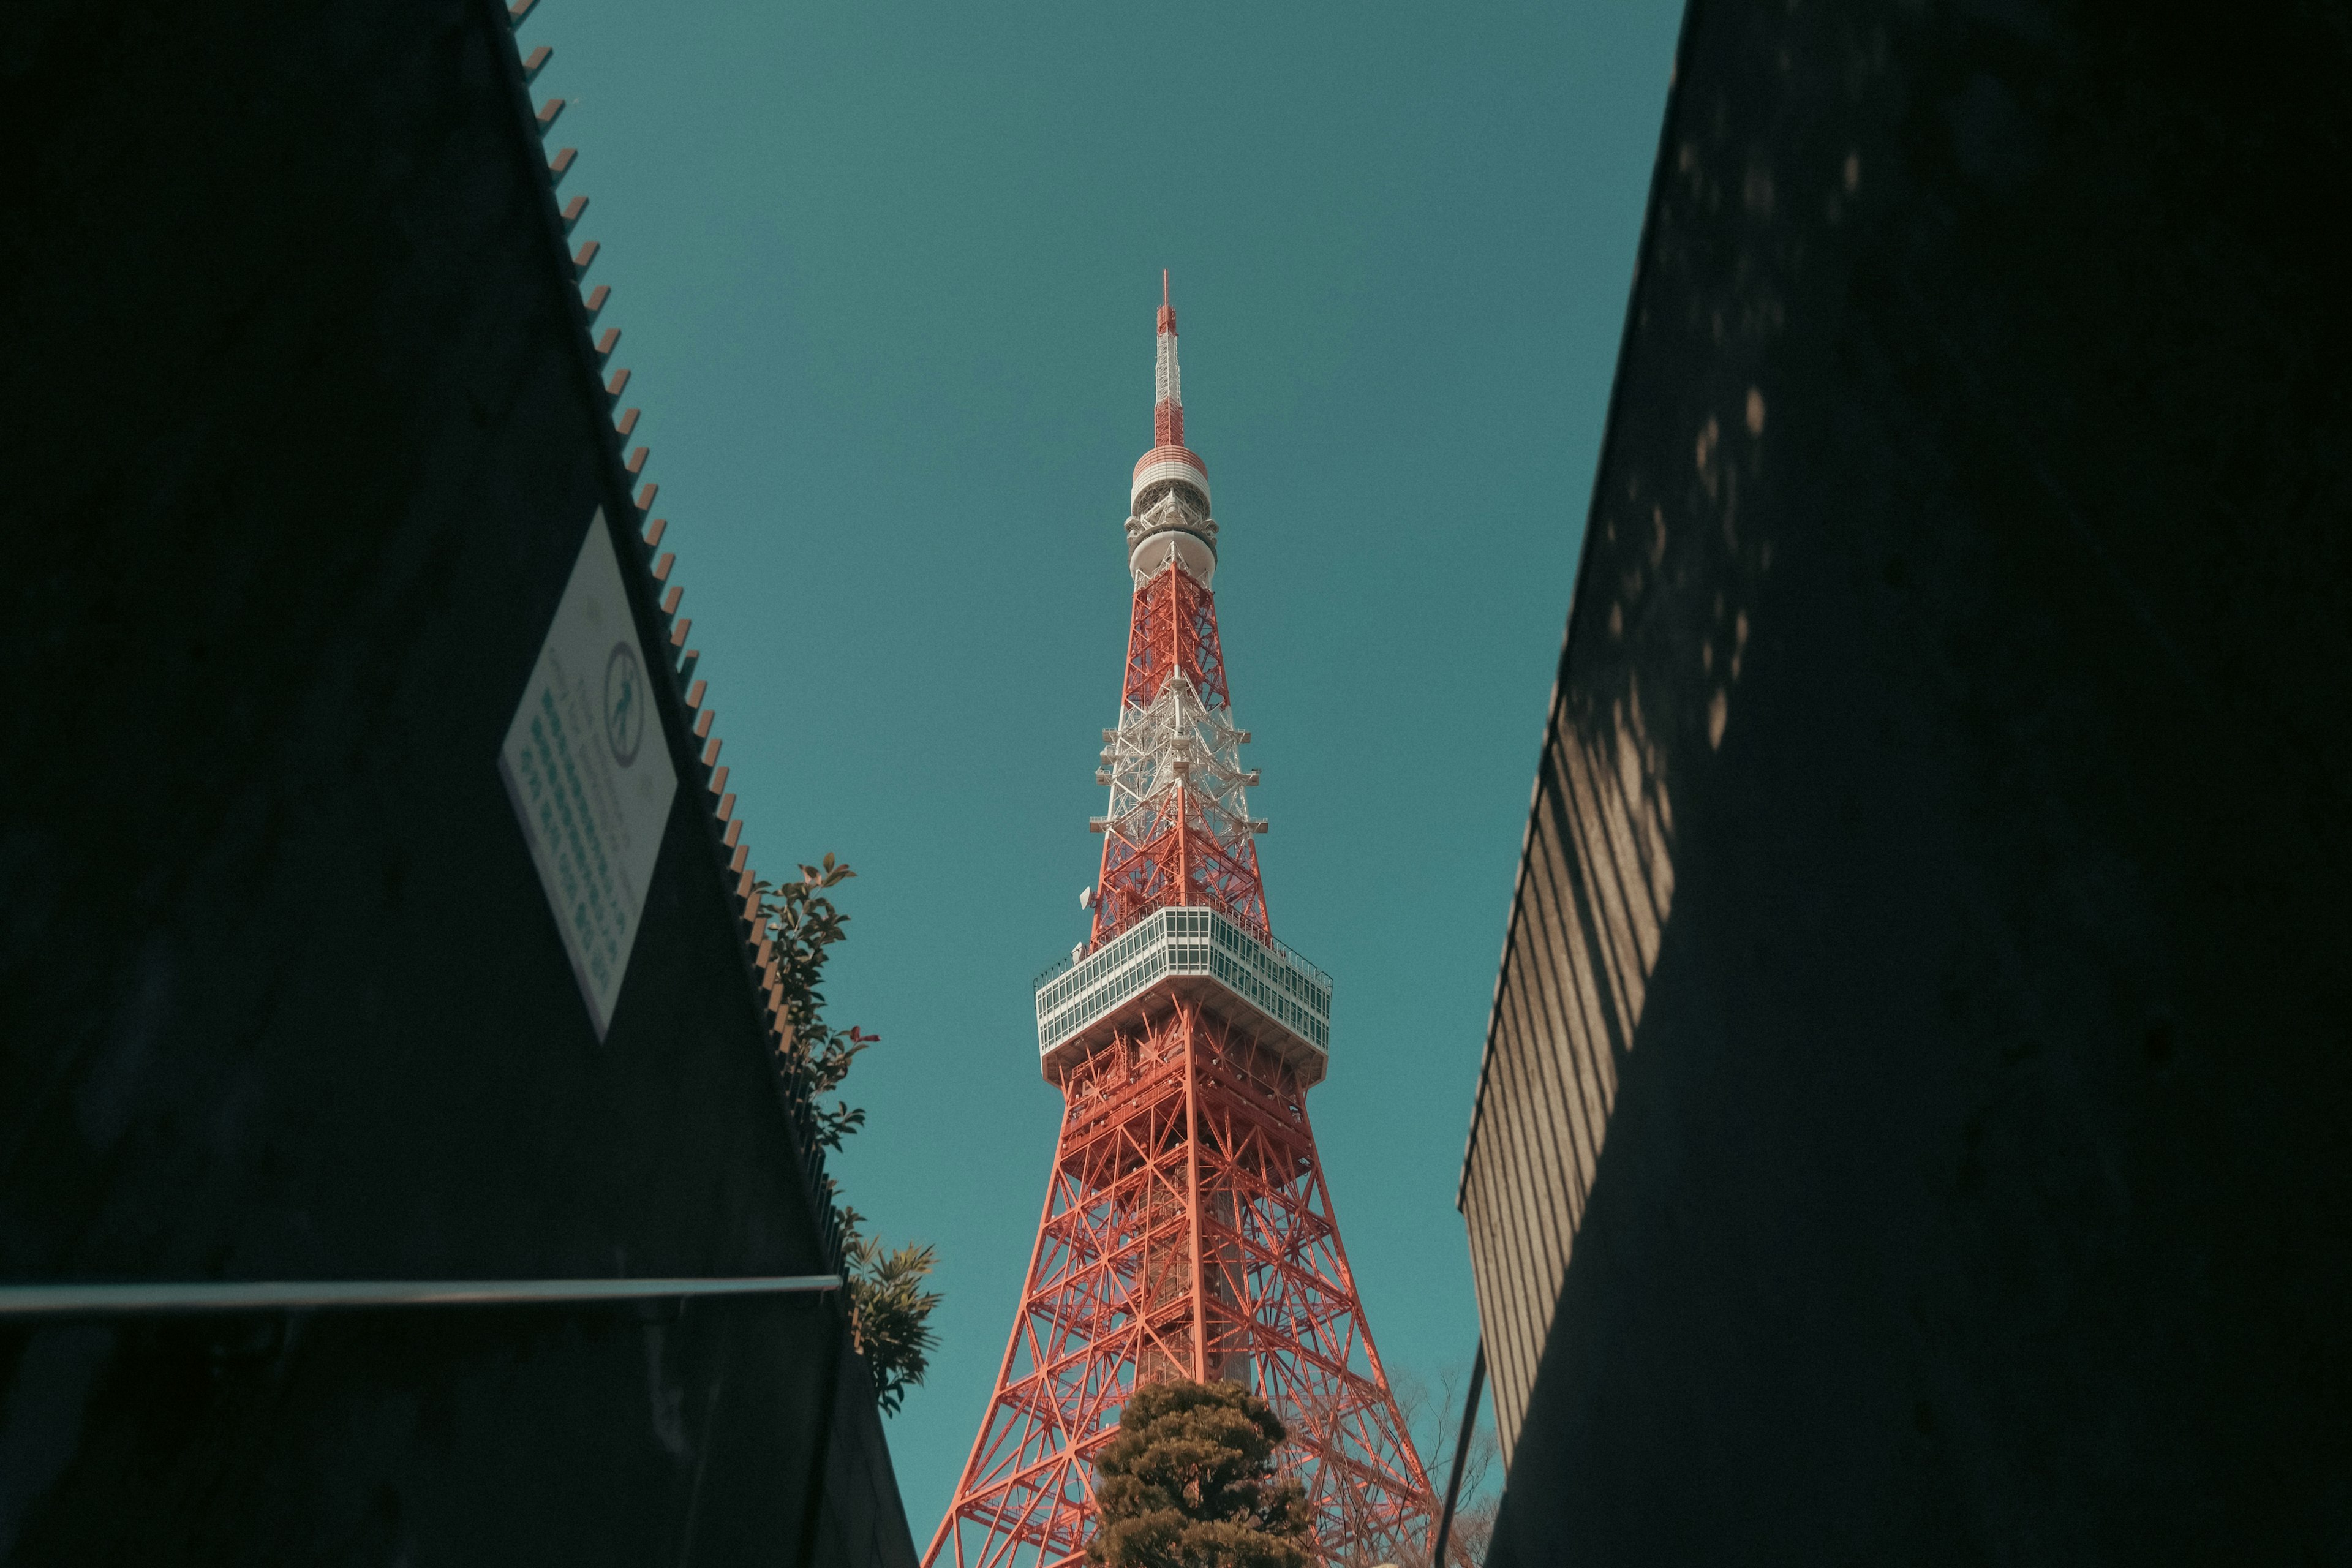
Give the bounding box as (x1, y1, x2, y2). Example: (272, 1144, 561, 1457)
(1491, 0, 2352, 1568)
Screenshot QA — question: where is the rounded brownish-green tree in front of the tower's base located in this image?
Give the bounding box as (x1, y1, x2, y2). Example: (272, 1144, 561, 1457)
(1087, 1380, 1313, 1568)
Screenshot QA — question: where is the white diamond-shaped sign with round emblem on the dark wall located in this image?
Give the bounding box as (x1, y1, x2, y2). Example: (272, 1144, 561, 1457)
(499, 508, 677, 1041)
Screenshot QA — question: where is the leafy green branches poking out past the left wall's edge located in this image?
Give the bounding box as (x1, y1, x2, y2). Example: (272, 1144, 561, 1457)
(753, 856, 941, 1415)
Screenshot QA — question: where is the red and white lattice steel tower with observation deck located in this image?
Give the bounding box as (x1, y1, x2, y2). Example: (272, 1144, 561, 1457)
(924, 275, 1437, 1568)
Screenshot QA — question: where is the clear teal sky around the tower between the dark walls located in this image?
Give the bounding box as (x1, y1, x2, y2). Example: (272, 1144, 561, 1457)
(522, 0, 1679, 1547)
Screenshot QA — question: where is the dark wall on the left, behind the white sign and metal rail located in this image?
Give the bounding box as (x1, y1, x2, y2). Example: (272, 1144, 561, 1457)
(0, 0, 913, 1563)
